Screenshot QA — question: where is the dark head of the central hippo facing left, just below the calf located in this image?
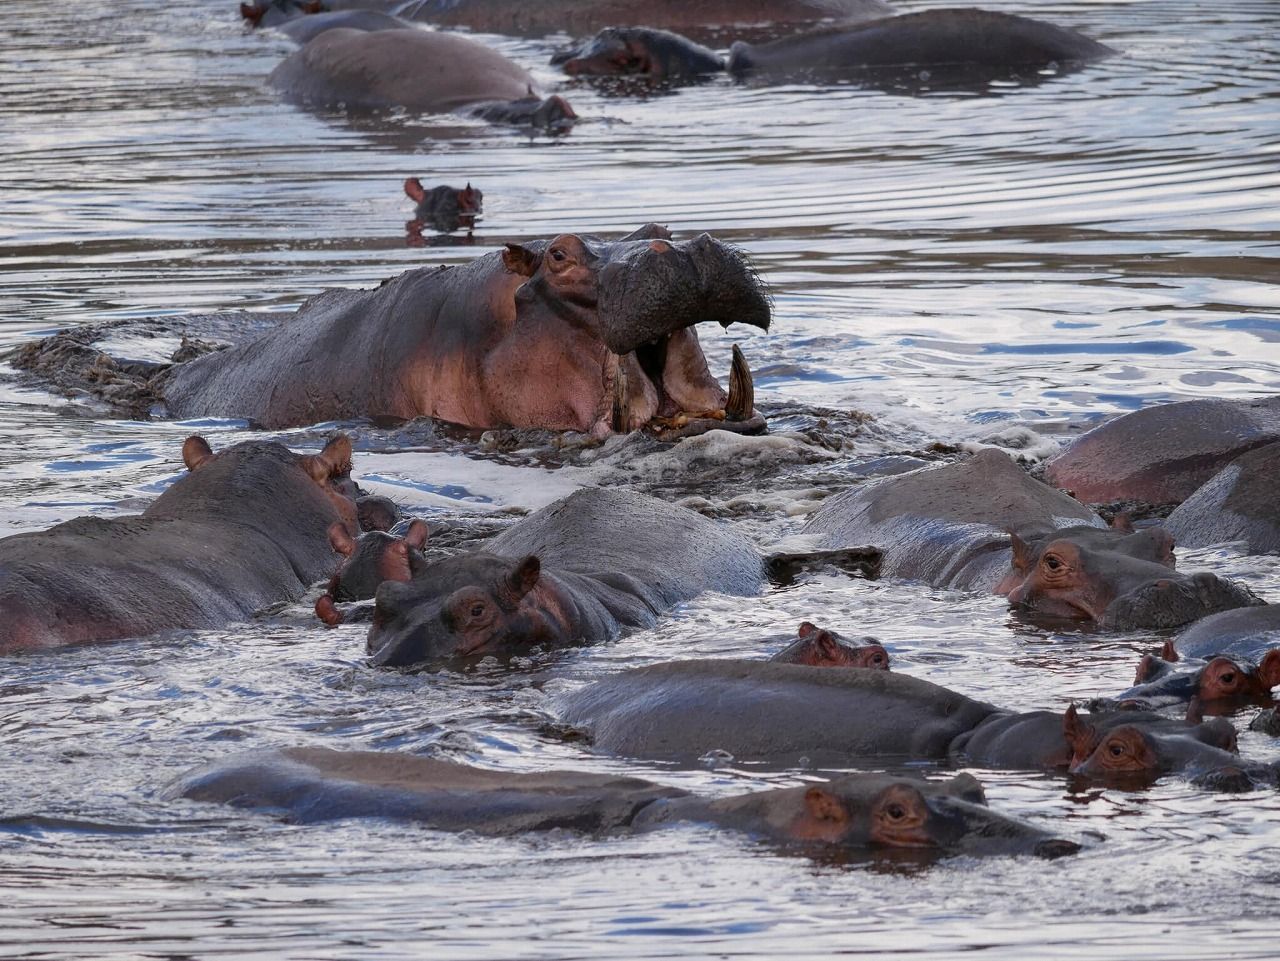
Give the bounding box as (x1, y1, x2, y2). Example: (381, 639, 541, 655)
(367, 553, 563, 667)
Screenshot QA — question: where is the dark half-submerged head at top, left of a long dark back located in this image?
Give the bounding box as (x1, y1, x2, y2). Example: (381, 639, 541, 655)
(552, 27, 724, 79)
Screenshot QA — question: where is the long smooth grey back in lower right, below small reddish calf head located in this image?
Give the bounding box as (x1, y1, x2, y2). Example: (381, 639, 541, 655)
(559, 660, 996, 765)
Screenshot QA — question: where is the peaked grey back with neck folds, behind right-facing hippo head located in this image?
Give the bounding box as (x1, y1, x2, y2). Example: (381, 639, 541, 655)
(804, 449, 1105, 590)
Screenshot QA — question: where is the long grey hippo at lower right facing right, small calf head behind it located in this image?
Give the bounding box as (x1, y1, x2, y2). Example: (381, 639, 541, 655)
(556, 660, 1239, 777)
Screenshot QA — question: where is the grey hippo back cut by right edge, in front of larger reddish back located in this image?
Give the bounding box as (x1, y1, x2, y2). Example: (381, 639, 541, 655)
(1165, 443, 1280, 554)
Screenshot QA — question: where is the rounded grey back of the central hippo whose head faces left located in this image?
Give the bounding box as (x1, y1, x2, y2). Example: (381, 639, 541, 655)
(485, 488, 764, 607)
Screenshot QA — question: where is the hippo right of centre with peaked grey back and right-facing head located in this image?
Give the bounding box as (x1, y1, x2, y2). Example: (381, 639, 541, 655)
(805, 449, 1261, 630)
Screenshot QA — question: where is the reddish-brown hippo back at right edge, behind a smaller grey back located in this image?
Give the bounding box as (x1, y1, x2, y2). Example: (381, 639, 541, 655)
(1044, 395, 1280, 505)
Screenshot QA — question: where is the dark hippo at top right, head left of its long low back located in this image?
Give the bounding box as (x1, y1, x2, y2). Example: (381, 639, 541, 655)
(552, 9, 1116, 81)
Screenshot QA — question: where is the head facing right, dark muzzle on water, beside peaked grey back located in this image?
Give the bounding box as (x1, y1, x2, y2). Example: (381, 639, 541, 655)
(996, 527, 1262, 630)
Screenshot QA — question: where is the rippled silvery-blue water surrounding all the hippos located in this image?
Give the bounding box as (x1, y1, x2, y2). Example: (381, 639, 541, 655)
(0, 0, 1280, 958)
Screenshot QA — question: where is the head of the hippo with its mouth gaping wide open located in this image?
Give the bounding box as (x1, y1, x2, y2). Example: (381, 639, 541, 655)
(503, 224, 769, 436)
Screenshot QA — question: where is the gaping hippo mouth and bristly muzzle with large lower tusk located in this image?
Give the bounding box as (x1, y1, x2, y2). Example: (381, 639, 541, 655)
(598, 234, 771, 439)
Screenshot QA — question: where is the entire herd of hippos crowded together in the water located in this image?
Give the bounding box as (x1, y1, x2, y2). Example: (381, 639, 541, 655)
(0, 0, 1280, 857)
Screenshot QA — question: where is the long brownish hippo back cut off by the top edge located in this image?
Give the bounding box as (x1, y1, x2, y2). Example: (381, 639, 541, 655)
(397, 0, 893, 36)
